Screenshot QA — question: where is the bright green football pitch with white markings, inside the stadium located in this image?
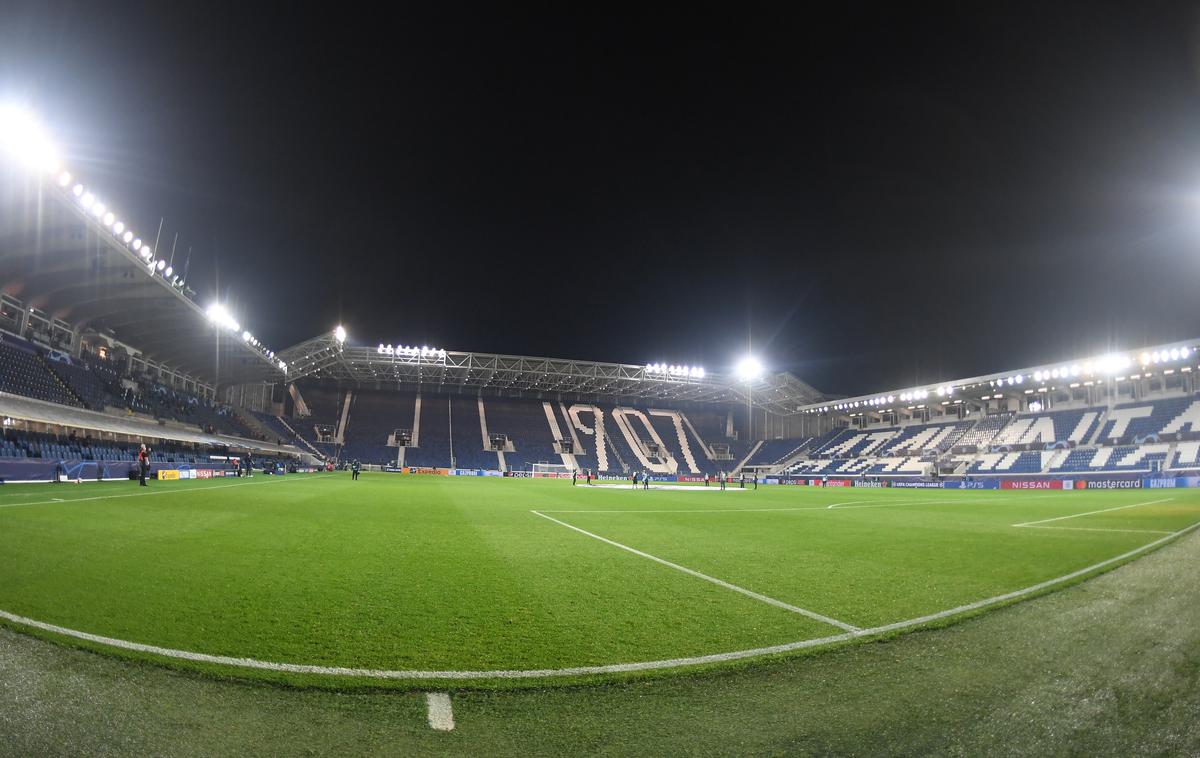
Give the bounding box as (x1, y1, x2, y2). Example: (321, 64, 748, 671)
(0, 473, 1200, 688)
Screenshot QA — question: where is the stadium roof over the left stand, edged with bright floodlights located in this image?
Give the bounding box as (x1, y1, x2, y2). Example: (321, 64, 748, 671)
(0, 167, 286, 385)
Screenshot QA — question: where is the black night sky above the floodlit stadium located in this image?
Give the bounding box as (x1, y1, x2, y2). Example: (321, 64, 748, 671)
(0, 1, 1200, 393)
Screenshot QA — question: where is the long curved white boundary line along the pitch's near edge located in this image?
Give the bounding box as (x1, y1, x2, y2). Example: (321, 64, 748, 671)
(0, 522, 1200, 680)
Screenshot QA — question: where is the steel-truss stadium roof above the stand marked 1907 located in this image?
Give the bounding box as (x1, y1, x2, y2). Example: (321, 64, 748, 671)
(280, 332, 824, 415)
